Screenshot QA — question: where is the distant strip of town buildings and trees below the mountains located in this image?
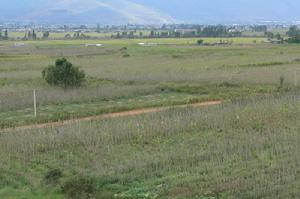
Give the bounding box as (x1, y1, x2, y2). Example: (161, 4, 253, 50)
(0, 23, 291, 40)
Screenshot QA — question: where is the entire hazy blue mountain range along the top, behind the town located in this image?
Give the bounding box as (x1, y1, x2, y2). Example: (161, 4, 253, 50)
(0, 0, 300, 24)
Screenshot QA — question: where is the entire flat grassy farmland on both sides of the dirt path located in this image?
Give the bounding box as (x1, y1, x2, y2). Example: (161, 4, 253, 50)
(0, 37, 300, 199)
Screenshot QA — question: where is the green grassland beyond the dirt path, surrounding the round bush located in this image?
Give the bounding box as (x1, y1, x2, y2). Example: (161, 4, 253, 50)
(0, 38, 300, 127)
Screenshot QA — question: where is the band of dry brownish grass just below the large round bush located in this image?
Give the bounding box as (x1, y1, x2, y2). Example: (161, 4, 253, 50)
(0, 85, 155, 111)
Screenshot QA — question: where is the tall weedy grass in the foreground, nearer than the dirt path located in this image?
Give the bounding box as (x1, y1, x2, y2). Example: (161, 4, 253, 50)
(0, 93, 300, 199)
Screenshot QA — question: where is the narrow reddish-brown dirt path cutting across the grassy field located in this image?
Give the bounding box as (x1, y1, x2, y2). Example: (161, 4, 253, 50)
(0, 101, 222, 133)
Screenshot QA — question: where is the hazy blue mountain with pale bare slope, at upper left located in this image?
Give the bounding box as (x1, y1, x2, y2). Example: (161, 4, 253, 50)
(0, 0, 179, 24)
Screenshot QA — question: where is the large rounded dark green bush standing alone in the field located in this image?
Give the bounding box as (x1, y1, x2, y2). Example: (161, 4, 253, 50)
(42, 58, 85, 88)
